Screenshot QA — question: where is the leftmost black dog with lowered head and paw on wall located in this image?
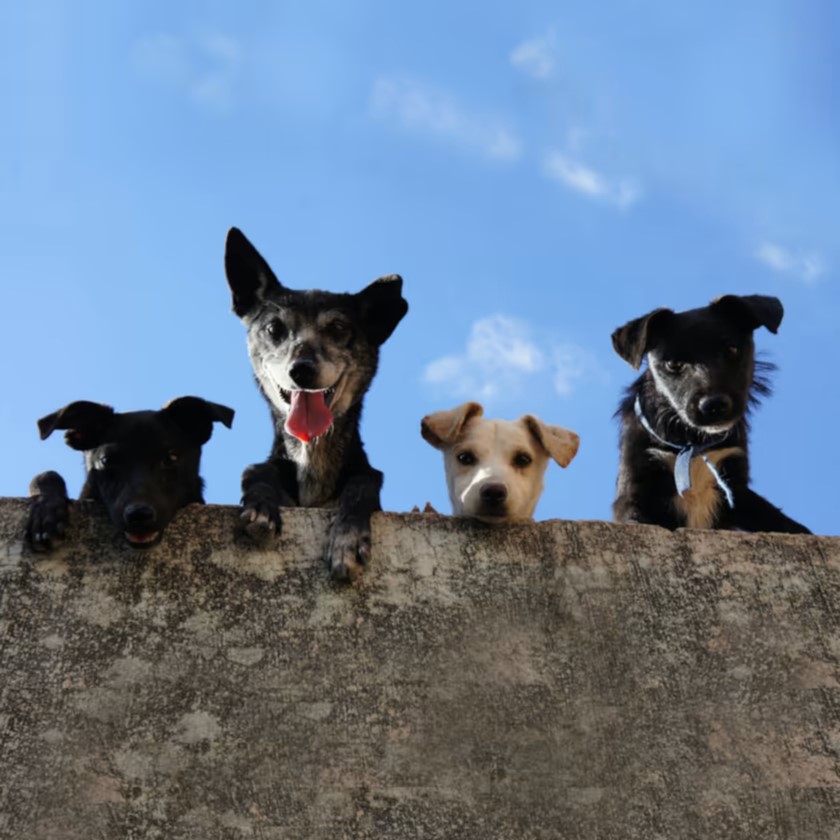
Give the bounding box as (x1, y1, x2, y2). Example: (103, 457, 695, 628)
(27, 397, 233, 551)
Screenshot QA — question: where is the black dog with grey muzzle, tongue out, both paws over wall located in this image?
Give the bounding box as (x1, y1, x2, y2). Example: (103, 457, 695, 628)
(225, 228, 408, 579)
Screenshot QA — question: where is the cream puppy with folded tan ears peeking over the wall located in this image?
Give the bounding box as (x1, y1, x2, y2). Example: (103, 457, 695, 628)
(420, 402, 580, 524)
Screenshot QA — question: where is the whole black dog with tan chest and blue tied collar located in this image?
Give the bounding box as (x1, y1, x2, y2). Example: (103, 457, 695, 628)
(612, 295, 810, 534)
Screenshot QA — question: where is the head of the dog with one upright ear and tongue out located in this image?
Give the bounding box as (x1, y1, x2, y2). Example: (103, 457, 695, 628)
(225, 228, 408, 443)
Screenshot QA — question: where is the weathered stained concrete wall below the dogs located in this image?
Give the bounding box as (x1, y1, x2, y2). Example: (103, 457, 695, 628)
(0, 500, 840, 840)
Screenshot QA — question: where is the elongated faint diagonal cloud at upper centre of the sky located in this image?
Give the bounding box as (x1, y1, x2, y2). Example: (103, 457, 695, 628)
(371, 79, 521, 160)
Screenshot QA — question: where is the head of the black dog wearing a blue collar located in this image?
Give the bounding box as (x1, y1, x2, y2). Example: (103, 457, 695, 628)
(612, 295, 784, 434)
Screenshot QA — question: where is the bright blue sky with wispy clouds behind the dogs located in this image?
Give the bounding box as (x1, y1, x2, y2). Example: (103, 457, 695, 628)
(0, 0, 840, 534)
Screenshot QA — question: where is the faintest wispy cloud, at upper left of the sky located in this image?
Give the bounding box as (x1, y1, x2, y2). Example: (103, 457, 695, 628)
(134, 33, 242, 114)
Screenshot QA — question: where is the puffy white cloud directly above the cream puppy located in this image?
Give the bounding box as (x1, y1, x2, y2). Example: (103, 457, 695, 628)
(423, 315, 603, 403)
